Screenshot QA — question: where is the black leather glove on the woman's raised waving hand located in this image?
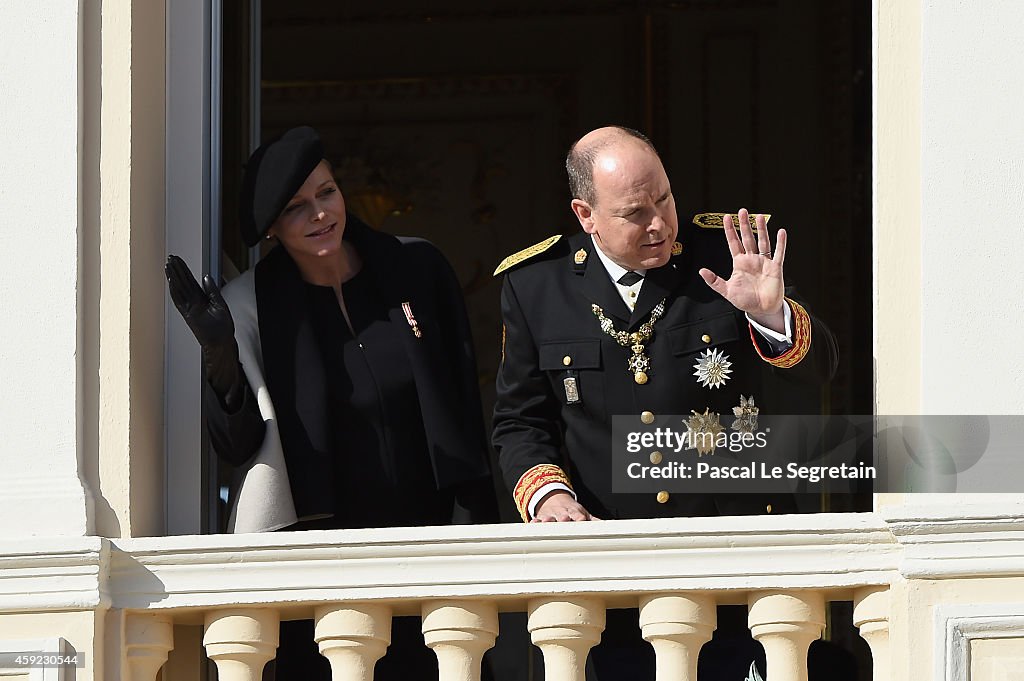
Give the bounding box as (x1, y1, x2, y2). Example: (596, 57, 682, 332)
(164, 255, 241, 403)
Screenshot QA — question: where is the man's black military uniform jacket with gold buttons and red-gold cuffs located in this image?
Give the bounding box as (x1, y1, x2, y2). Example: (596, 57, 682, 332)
(493, 232, 837, 518)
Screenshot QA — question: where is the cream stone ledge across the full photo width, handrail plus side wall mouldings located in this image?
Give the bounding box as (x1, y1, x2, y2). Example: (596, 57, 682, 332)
(8, 507, 1024, 616)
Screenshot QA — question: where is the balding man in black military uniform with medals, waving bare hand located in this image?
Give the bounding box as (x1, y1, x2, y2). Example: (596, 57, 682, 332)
(494, 127, 837, 521)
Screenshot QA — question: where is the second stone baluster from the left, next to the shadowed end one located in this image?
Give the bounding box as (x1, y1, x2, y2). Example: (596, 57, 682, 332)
(203, 608, 280, 681)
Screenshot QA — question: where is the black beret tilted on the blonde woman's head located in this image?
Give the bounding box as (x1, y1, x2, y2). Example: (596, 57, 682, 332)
(239, 126, 324, 246)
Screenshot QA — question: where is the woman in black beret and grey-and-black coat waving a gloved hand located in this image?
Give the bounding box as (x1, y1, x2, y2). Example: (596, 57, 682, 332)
(166, 127, 497, 679)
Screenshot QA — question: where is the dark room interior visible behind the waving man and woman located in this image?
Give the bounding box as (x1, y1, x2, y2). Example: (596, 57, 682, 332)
(222, 0, 872, 510)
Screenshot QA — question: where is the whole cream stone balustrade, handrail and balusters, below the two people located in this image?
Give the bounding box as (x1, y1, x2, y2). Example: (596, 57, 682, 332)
(97, 513, 900, 681)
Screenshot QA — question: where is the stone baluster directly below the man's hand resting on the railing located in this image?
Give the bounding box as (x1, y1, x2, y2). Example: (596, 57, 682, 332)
(526, 597, 604, 681)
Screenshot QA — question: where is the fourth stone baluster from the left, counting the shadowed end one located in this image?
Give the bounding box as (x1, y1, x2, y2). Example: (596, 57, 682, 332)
(422, 601, 498, 681)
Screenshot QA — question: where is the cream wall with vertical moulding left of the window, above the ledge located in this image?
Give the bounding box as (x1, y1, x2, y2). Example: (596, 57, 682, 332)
(0, 0, 166, 537)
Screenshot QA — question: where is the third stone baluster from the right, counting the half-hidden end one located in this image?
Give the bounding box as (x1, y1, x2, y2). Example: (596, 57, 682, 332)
(640, 594, 718, 681)
